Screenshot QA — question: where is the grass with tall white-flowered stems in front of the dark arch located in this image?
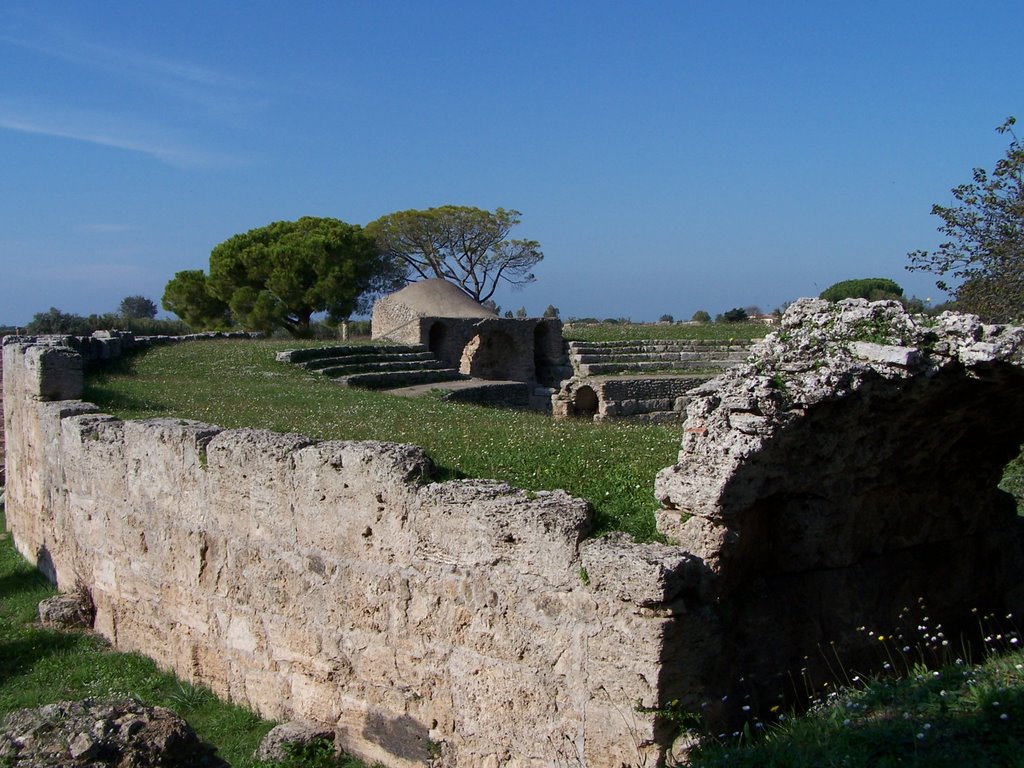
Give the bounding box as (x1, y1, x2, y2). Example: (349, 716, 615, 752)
(669, 599, 1024, 768)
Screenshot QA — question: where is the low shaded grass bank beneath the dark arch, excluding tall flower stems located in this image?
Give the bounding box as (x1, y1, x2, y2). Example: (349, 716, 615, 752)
(690, 651, 1024, 768)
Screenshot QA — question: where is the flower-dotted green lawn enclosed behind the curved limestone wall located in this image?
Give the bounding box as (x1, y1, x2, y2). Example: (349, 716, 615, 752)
(84, 341, 680, 541)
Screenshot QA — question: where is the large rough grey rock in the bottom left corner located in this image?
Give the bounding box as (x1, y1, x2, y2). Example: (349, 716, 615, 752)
(0, 698, 228, 768)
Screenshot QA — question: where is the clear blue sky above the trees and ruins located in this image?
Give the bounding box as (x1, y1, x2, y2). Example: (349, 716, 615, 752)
(0, 0, 1024, 325)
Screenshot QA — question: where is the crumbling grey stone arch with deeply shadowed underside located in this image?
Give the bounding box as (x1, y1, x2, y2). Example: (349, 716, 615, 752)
(655, 299, 1024, 720)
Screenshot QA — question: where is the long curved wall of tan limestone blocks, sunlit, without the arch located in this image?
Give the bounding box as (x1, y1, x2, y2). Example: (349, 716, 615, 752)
(3, 343, 685, 768)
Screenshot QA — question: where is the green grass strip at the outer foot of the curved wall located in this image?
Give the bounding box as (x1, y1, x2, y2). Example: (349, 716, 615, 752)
(0, 508, 361, 768)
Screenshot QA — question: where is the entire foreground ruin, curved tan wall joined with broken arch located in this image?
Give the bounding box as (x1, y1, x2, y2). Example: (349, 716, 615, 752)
(3, 300, 1024, 768)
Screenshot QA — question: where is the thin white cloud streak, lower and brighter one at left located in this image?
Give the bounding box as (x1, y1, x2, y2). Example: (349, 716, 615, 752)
(0, 101, 248, 167)
